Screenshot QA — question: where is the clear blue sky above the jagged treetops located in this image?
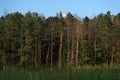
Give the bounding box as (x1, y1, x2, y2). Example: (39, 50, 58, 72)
(0, 0, 120, 17)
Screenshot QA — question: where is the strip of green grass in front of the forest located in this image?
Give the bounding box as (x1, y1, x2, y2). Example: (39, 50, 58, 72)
(0, 67, 120, 80)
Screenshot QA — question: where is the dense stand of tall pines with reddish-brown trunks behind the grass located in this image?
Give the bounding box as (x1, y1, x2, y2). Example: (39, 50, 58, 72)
(0, 11, 120, 70)
